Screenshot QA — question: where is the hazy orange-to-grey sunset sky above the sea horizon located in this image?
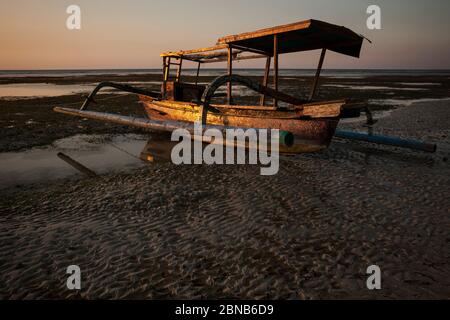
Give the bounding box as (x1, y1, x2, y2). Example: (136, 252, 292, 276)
(0, 0, 450, 70)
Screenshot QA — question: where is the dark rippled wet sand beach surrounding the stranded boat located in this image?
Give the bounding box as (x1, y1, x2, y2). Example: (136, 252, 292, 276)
(0, 76, 450, 299)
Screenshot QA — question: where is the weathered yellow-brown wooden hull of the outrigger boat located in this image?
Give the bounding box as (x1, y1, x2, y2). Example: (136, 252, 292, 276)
(140, 96, 339, 153)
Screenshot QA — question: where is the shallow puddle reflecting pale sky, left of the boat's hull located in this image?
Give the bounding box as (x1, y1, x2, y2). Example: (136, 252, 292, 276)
(0, 135, 149, 189)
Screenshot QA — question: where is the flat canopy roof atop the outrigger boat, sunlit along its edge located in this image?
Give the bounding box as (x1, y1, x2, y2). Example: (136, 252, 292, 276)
(161, 19, 364, 63)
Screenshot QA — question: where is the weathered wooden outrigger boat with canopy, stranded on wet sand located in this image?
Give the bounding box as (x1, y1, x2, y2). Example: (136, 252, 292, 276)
(55, 20, 435, 153)
